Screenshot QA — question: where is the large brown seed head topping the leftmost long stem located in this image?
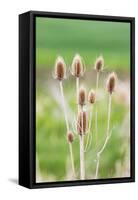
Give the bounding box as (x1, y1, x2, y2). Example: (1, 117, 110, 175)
(55, 56, 66, 81)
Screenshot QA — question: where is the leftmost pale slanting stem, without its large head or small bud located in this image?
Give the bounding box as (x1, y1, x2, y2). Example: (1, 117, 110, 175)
(59, 81, 76, 177)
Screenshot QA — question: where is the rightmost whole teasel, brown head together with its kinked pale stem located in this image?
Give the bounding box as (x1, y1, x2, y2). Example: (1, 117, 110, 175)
(95, 72, 117, 179)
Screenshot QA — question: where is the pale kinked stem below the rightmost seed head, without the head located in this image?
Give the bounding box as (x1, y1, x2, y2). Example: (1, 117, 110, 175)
(95, 94, 112, 179)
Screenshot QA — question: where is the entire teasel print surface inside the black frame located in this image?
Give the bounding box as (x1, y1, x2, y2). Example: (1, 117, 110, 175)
(35, 17, 130, 183)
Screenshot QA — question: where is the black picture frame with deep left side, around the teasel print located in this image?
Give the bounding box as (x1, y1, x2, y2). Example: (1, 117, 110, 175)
(19, 11, 135, 188)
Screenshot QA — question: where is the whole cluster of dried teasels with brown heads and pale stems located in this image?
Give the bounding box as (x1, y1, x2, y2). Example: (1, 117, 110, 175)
(54, 54, 117, 180)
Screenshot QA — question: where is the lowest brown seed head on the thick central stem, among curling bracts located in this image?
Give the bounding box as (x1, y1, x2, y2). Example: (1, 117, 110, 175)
(77, 111, 88, 135)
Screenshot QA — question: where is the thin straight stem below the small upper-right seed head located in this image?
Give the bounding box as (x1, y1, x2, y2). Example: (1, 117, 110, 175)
(95, 72, 100, 146)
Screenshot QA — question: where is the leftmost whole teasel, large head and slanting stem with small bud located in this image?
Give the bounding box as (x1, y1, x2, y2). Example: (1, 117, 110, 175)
(55, 57, 75, 177)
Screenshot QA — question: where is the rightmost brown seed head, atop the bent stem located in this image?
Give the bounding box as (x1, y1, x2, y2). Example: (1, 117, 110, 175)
(107, 72, 117, 94)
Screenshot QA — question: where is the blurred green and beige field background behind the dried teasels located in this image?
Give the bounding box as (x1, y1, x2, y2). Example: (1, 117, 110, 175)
(36, 17, 130, 182)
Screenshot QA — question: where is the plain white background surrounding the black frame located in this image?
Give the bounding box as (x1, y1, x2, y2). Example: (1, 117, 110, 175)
(0, 0, 138, 200)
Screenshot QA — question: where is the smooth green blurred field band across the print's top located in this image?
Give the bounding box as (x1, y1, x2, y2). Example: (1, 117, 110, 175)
(36, 18, 130, 69)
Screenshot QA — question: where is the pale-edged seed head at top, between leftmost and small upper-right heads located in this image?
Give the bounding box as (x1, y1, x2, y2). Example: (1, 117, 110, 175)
(71, 54, 84, 77)
